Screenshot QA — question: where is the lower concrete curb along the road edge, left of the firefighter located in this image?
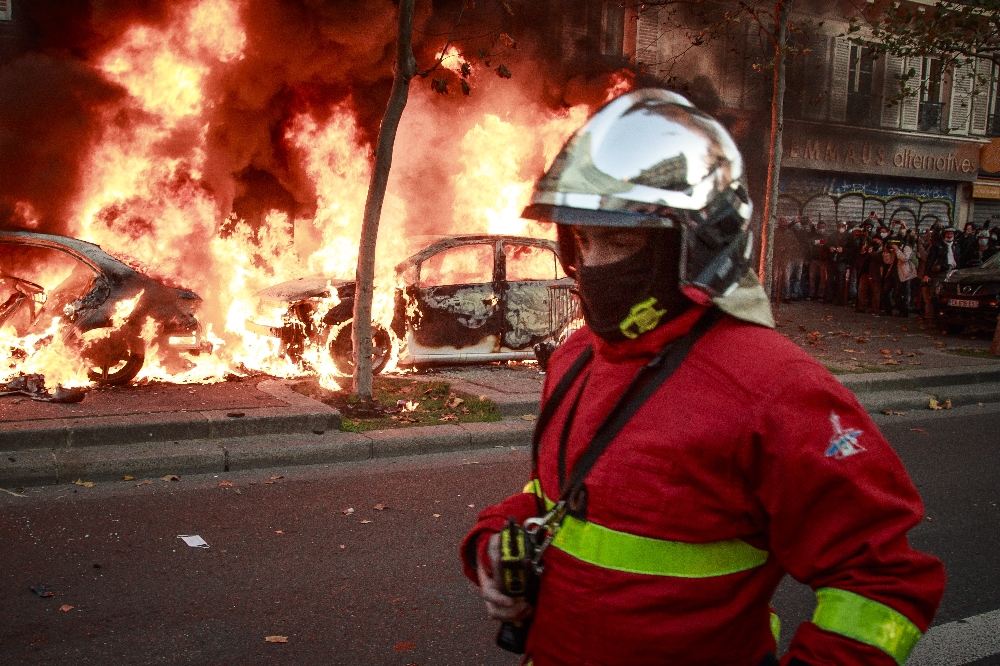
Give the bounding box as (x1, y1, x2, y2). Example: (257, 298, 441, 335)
(0, 420, 534, 486)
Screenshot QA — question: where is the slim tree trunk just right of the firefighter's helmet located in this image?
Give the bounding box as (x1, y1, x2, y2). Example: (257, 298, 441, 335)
(758, 0, 792, 294)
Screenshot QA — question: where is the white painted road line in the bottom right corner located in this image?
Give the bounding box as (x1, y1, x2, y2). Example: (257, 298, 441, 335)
(906, 610, 1000, 666)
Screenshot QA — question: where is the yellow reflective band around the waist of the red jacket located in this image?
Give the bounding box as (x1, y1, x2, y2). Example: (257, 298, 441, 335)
(524, 479, 767, 578)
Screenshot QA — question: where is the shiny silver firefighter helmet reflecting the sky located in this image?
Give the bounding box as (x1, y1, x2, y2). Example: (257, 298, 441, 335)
(522, 88, 753, 298)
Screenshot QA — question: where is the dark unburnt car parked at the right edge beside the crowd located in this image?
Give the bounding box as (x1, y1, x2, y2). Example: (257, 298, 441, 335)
(935, 254, 1000, 334)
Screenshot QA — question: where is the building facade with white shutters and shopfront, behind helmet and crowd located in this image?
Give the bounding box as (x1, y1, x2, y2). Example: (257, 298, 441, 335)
(627, 2, 1000, 228)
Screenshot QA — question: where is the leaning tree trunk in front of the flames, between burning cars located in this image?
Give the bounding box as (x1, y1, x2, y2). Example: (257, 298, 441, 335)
(352, 0, 417, 401)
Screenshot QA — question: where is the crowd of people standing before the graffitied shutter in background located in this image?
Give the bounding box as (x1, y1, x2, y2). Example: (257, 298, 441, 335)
(772, 212, 1000, 320)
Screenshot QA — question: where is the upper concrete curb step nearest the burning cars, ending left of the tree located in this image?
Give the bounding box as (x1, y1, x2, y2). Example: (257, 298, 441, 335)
(0, 379, 340, 451)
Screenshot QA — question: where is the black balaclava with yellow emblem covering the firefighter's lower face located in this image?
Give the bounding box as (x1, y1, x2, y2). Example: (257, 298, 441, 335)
(576, 229, 691, 342)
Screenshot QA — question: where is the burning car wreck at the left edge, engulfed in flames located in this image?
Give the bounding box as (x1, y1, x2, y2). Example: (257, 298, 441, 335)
(0, 229, 212, 385)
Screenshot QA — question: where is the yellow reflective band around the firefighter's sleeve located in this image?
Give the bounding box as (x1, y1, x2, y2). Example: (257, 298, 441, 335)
(813, 587, 923, 666)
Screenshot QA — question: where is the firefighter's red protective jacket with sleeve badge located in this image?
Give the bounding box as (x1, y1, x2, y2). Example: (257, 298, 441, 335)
(461, 307, 945, 666)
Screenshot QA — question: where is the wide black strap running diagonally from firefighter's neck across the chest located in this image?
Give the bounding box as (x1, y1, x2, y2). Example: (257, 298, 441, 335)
(559, 307, 723, 501)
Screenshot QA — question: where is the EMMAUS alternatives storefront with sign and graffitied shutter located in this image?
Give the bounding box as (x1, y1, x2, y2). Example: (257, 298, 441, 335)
(778, 121, 982, 229)
